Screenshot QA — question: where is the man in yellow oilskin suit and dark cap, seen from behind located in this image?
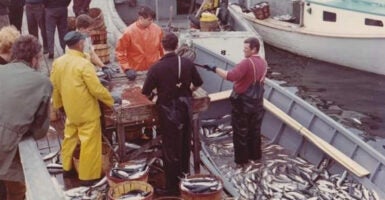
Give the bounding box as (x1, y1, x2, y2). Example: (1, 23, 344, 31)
(51, 31, 121, 186)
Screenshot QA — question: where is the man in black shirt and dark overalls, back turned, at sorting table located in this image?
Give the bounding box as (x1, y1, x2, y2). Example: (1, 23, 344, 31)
(142, 33, 203, 195)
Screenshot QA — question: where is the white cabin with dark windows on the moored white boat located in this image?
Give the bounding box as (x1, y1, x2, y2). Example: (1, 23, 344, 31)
(303, 0, 385, 37)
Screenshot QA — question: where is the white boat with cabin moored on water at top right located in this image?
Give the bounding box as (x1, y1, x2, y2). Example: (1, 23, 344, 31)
(233, 0, 385, 75)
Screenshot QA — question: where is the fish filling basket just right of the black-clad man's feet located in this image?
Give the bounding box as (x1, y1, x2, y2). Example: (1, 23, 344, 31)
(181, 176, 223, 193)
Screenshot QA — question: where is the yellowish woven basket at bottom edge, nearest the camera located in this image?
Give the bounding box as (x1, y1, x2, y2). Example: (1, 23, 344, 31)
(108, 181, 154, 200)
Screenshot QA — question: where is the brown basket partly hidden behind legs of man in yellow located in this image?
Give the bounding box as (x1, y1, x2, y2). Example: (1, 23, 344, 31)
(72, 143, 112, 174)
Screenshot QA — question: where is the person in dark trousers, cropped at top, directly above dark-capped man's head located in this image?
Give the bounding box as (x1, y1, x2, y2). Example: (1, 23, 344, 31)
(44, 0, 71, 59)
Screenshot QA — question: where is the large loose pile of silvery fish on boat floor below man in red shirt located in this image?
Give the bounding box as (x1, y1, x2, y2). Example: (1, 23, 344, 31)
(214, 145, 379, 200)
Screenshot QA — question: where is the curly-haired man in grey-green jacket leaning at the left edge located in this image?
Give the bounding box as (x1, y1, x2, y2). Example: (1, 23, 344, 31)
(0, 35, 52, 200)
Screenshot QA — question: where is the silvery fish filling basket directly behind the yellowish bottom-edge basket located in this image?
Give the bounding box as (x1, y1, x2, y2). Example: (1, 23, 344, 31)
(110, 163, 149, 180)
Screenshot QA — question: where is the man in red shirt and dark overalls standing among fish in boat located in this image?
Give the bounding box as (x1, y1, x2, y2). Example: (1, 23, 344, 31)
(204, 37, 267, 165)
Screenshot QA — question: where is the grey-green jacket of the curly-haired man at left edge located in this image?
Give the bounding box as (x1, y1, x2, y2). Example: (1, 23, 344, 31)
(0, 62, 52, 181)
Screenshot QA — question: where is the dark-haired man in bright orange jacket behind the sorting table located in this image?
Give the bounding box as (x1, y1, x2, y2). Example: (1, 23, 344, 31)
(115, 6, 163, 80)
